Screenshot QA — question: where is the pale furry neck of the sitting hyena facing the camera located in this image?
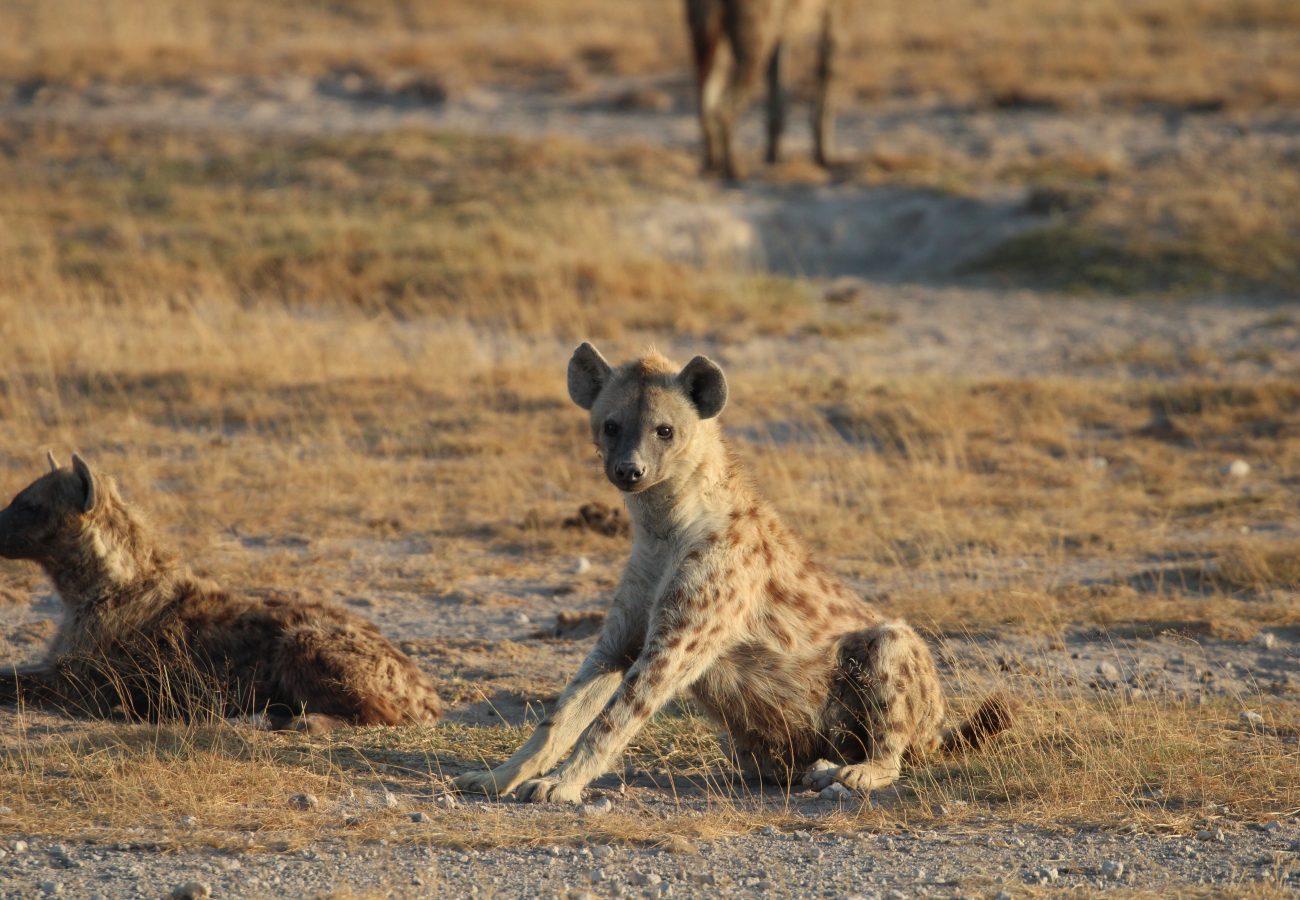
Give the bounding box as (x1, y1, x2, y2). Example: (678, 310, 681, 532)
(628, 436, 758, 538)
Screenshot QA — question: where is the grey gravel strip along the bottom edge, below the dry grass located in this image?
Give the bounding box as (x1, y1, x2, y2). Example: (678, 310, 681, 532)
(0, 816, 1300, 900)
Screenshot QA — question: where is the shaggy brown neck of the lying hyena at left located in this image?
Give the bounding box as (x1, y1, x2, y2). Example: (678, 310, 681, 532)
(44, 497, 174, 609)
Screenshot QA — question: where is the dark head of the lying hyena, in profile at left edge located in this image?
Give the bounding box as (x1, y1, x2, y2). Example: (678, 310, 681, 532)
(0, 454, 99, 561)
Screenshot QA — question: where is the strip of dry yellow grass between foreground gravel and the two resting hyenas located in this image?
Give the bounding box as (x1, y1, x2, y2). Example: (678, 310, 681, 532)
(0, 683, 1300, 852)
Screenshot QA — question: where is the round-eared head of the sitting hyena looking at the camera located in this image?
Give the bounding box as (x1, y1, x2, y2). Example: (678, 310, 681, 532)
(568, 343, 727, 493)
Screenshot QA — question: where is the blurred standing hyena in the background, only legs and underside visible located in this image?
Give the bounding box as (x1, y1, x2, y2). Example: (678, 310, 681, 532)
(686, 0, 844, 178)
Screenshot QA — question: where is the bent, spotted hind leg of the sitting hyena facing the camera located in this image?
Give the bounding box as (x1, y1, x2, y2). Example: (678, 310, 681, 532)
(807, 622, 944, 791)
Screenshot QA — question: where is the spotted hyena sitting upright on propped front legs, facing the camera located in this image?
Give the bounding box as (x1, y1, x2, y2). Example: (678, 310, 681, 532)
(456, 343, 1011, 801)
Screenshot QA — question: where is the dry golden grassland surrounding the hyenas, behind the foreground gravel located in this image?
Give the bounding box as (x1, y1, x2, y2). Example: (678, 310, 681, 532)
(0, 0, 1300, 892)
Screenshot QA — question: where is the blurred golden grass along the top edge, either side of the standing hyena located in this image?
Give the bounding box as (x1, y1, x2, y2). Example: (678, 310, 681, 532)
(0, 0, 1300, 111)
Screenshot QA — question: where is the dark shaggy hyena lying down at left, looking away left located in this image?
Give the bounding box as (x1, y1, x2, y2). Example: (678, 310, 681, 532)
(0, 455, 442, 732)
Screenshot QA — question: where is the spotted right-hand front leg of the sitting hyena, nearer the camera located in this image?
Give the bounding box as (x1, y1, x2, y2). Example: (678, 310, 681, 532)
(517, 628, 720, 802)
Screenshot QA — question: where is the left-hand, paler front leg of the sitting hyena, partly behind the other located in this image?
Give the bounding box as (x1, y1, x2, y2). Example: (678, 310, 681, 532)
(454, 648, 623, 795)
